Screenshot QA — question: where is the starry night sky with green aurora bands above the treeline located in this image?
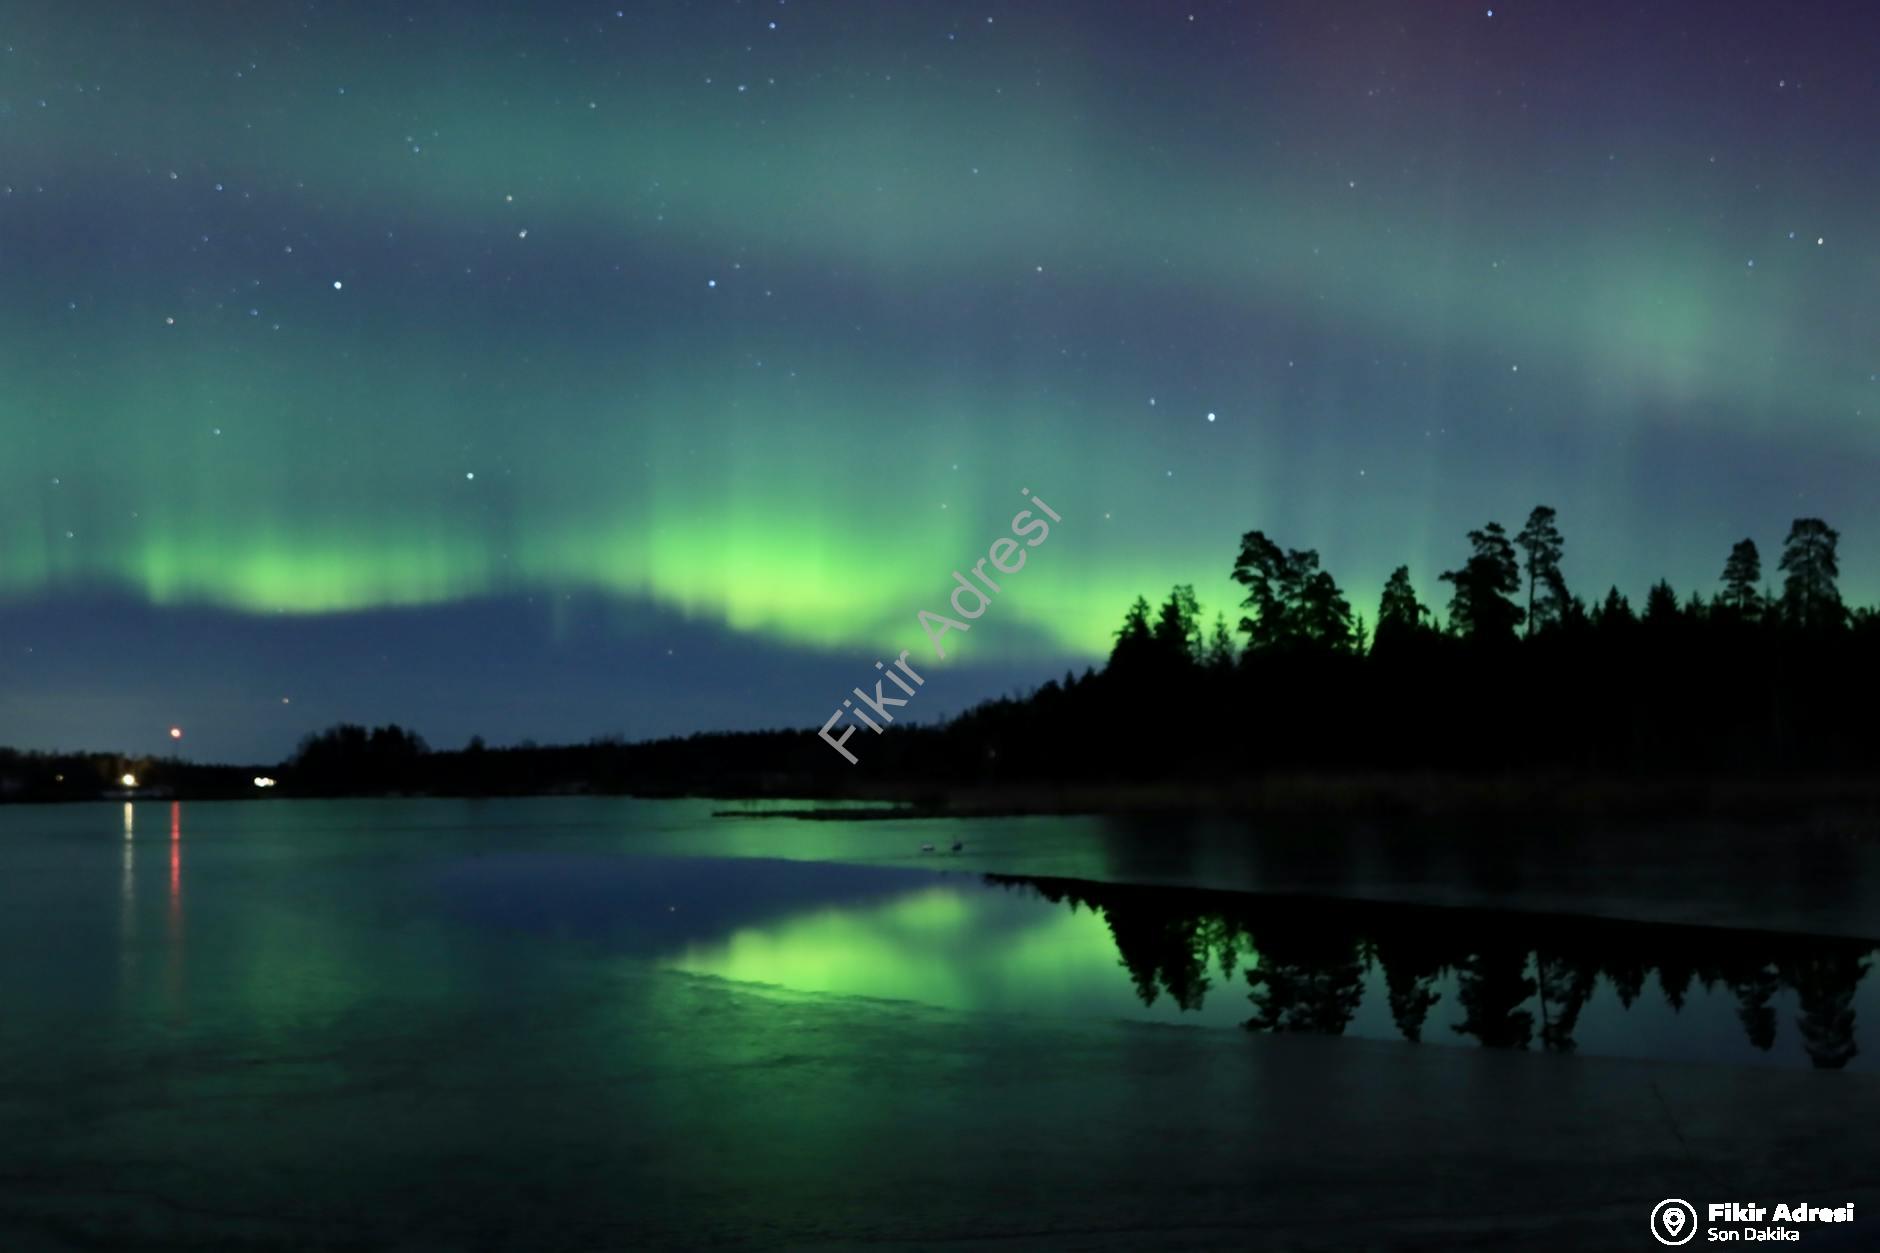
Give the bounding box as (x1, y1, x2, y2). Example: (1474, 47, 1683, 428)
(0, 0, 1880, 760)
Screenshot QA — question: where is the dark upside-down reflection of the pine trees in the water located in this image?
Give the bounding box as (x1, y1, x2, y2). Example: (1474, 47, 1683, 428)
(989, 875, 1874, 1069)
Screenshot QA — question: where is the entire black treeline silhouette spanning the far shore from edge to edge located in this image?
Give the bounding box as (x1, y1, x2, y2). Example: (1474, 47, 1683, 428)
(11, 506, 1880, 800)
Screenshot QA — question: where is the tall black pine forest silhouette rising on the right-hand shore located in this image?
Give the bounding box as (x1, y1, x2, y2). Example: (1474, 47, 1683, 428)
(948, 506, 1880, 779)
